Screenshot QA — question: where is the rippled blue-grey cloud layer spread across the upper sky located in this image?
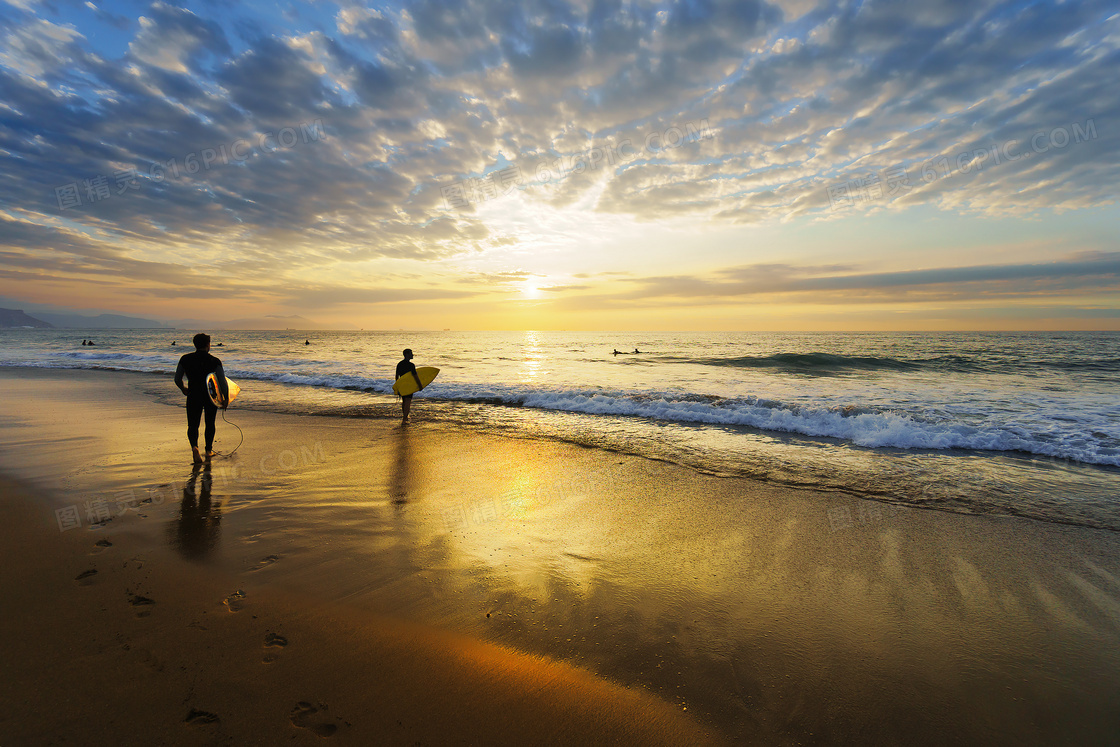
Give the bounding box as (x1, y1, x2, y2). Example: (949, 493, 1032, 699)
(0, 0, 1120, 309)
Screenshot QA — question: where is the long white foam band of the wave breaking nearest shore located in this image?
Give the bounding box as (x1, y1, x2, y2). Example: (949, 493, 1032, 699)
(4, 351, 1120, 466)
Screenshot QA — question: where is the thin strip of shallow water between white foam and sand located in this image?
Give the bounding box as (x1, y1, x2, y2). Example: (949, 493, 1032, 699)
(0, 358, 1120, 533)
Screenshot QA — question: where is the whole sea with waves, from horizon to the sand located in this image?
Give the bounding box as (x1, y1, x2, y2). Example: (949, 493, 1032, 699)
(0, 329, 1120, 531)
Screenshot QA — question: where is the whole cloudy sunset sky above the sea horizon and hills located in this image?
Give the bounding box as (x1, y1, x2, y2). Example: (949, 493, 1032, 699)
(0, 0, 1120, 330)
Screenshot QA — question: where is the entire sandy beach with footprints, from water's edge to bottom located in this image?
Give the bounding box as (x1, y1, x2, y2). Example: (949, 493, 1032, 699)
(0, 368, 1120, 745)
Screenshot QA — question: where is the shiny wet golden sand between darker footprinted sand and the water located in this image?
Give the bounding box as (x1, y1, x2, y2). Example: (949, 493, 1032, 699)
(0, 370, 1120, 744)
